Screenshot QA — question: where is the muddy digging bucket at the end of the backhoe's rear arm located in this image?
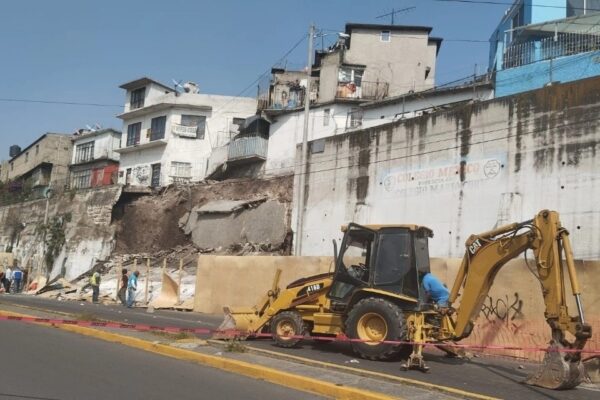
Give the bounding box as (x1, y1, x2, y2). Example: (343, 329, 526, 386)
(525, 344, 585, 390)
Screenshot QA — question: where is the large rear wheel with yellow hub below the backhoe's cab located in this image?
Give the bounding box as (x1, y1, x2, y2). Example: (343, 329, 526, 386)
(345, 297, 412, 360)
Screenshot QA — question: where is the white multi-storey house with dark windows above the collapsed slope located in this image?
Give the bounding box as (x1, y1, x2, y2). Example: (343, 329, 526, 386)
(117, 77, 256, 187)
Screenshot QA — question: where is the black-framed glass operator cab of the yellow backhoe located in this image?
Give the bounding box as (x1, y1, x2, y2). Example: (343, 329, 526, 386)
(327, 223, 433, 310)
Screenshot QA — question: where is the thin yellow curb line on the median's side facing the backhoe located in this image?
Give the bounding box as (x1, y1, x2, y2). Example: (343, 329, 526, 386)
(207, 339, 500, 400)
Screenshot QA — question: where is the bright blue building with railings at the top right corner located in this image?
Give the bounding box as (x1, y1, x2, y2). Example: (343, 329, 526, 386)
(489, 0, 600, 97)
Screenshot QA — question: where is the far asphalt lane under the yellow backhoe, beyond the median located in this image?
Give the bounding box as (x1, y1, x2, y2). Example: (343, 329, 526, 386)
(0, 295, 600, 400)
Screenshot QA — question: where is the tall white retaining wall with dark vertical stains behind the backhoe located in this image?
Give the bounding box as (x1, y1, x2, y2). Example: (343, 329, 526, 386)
(292, 77, 600, 260)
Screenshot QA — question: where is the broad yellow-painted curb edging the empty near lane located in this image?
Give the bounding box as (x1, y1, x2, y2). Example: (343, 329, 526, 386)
(0, 310, 398, 400)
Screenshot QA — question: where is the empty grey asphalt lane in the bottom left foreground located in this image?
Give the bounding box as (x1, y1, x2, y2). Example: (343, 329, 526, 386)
(0, 314, 320, 400)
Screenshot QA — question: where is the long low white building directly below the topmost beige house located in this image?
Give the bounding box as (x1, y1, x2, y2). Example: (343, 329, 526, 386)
(263, 77, 494, 175)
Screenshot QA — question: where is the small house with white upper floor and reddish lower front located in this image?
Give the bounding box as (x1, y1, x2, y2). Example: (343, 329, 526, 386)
(69, 129, 121, 189)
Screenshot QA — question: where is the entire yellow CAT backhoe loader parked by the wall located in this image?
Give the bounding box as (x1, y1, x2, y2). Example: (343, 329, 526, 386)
(220, 210, 591, 389)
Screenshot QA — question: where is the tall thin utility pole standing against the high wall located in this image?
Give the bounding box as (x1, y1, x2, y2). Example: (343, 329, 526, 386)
(294, 24, 315, 256)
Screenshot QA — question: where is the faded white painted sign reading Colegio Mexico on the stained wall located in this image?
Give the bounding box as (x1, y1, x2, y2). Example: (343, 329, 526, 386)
(380, 157, 504, 195)
